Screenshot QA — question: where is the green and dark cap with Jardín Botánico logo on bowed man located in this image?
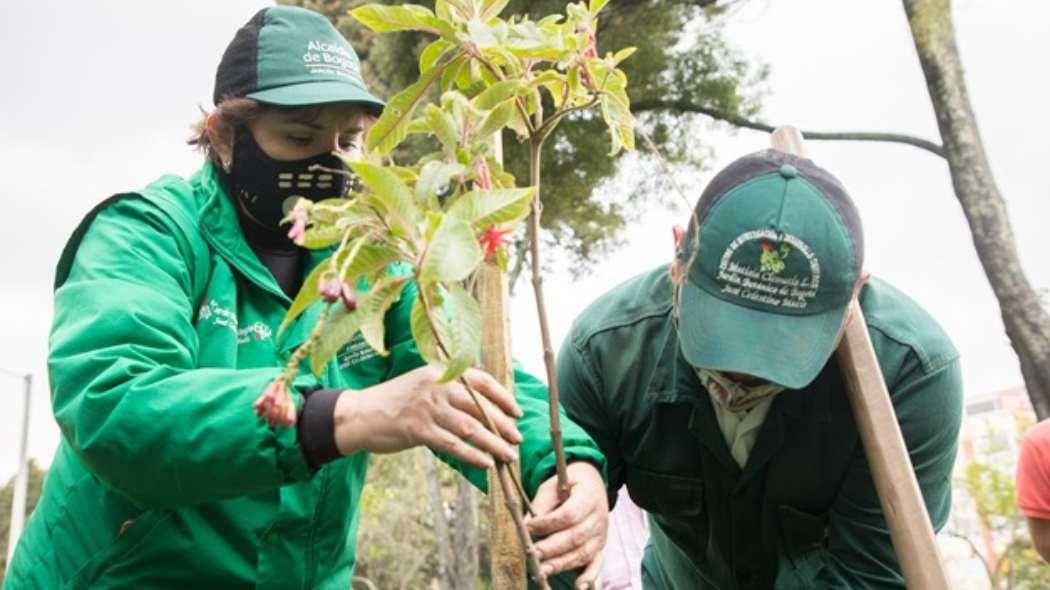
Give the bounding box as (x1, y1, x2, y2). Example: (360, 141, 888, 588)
(678, 149, 864, 388)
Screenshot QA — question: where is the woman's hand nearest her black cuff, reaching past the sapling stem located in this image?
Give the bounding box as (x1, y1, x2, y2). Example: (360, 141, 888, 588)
(335, 366, 522, 468)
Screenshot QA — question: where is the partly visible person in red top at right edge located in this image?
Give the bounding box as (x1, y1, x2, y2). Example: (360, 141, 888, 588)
(1017, 420, 1050, 562)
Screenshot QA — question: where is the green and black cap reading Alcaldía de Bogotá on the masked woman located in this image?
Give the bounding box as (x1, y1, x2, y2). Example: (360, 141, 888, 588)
(212, 6, 384, 114)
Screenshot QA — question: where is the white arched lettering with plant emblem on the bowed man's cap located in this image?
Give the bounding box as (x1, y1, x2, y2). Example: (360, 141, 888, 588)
(716, 229, 820, 310)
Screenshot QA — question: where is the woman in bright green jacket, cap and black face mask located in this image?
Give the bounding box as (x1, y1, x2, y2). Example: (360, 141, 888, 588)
(5, 6, 607, 590)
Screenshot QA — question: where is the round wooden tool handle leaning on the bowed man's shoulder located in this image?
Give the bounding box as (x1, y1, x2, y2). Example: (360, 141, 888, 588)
(772, 126, 949, 590)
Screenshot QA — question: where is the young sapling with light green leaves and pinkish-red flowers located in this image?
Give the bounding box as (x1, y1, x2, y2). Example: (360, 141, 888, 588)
(255, 0, 634, 587)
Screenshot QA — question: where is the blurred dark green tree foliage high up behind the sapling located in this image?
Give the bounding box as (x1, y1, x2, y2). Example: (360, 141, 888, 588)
(278, 0, 767, 278)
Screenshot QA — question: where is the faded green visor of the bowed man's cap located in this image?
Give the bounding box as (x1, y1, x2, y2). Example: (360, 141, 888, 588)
(678, 281, 846, 389)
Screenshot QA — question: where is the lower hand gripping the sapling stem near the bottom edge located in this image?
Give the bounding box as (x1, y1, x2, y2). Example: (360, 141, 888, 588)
(525, 462, 609, 589)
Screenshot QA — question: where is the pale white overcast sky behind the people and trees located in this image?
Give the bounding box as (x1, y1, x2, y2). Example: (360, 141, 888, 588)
(0, 0, 1050, 480)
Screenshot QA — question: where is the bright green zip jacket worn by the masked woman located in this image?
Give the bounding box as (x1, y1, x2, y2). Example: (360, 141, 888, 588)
(5, 161, 604, 590)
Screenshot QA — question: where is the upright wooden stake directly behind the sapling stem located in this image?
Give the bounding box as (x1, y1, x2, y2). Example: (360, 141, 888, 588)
(476, 133, 526, 589)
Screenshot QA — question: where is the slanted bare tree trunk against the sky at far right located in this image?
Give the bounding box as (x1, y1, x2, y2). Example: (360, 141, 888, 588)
(903, 0, 1050, 420)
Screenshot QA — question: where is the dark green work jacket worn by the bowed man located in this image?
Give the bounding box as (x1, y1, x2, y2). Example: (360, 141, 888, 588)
(558, 267, 962, 590)
